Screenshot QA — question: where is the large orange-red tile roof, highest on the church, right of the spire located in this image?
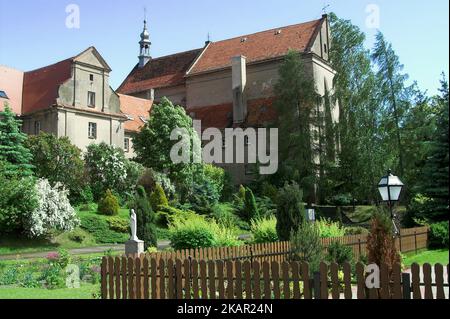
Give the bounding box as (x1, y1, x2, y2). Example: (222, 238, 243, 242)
(189, 18, 324, 75)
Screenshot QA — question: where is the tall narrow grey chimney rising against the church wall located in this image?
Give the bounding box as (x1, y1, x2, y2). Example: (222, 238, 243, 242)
(231, 55, 247, 123)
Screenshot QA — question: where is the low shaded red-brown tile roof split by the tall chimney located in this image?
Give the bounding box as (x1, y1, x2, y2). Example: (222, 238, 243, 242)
(186, 97, 277, 129)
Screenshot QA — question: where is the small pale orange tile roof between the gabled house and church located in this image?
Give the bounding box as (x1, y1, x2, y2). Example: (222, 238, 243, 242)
(119, 94, 153, 132)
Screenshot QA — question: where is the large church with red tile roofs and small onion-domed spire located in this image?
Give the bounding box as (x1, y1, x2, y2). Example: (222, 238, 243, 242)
(117, 15, 339, 183)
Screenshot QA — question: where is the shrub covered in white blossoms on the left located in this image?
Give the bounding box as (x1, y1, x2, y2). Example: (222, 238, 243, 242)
(25, 179, 80, 237)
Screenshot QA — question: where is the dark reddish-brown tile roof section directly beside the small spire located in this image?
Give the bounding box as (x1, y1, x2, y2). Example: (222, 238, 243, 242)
(117, 49, 202, 94)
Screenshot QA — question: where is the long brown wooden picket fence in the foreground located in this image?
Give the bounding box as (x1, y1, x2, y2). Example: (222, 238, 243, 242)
(101, 254, 449, 299)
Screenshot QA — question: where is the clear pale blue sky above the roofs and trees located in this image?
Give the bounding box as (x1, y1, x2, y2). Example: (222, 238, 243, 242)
(0, 0, 449, 94)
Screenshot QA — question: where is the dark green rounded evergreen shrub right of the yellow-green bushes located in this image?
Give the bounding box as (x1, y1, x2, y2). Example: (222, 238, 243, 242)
(276, 182, 306, 241)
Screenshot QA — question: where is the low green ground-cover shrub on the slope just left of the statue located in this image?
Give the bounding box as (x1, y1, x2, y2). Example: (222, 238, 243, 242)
(81, 215, 130, 244)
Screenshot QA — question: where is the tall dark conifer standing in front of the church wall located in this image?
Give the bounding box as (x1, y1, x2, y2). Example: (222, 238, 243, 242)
(275, 51, 319, 197)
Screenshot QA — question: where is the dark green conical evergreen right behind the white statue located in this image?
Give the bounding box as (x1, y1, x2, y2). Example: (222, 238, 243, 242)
(134, 185, 158, 250)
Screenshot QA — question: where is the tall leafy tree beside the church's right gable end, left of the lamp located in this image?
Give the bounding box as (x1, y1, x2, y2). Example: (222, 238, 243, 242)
(330, 13, 387, 200)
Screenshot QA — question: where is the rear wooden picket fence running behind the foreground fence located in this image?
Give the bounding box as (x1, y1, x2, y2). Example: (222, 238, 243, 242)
(144, 227, 428, 263)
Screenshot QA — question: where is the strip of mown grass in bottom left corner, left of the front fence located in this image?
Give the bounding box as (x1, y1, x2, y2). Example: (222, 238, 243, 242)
(0, 284, 100, 299)
